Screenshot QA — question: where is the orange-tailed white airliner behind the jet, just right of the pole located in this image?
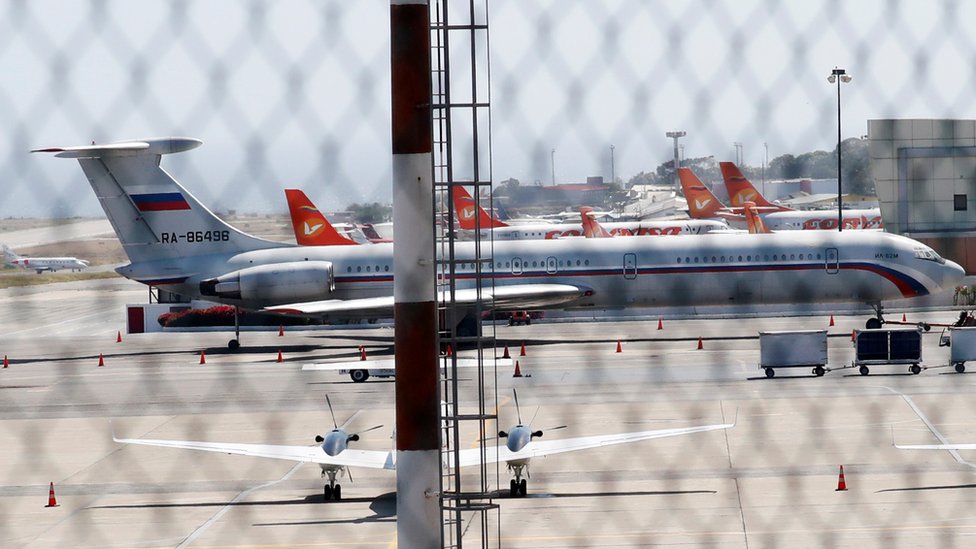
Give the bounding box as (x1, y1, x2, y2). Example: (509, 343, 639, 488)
(454, 186, 729, 240)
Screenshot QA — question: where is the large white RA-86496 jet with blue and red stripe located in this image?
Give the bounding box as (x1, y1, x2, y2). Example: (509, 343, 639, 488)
(34, 137, 964, 342)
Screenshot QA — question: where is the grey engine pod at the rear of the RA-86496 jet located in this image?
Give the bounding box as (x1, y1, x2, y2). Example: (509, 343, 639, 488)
(200, 261, 335, 302)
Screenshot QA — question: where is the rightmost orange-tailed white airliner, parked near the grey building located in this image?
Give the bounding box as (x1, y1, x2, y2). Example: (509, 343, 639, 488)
(719, 162, 884, 231)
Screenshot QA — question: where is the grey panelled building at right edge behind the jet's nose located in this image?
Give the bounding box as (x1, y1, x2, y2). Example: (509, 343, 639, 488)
(868, 119, 976, 274)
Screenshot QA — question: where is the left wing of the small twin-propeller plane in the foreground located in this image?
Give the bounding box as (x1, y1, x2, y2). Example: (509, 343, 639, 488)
(112, 434, 395, 470)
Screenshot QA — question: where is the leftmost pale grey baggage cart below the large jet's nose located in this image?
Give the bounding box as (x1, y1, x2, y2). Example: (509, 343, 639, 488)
(759, 330, 827, 377)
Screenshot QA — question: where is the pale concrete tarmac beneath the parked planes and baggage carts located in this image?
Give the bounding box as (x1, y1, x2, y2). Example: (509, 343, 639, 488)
(0, 279, 976, 549)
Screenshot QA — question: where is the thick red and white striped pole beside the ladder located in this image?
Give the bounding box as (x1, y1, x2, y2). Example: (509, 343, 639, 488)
(390, 0, 442, 548)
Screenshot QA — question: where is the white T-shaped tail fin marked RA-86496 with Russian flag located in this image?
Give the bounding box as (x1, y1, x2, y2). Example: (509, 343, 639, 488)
(31, 137, 282, 263)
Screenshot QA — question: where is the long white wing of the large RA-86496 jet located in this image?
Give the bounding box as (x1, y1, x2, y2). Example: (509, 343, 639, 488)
(264, 284, 592, 316)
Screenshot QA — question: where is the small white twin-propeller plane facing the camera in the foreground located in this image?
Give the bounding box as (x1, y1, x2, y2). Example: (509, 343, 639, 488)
(112, 394, 735, 500)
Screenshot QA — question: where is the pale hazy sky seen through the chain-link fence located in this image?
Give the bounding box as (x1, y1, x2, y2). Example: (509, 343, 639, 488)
(0, 0, 976, 217)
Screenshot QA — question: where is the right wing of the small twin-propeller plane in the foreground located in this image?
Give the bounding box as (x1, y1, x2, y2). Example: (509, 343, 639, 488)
(459, 423, 735, 467)
